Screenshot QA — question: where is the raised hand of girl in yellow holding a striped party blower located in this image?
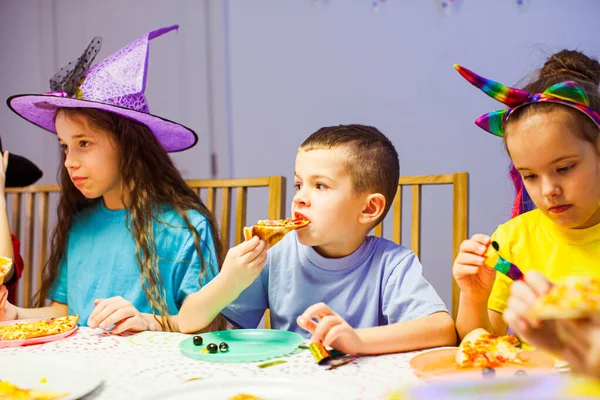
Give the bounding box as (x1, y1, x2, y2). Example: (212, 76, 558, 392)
(452, 234, 496, 299)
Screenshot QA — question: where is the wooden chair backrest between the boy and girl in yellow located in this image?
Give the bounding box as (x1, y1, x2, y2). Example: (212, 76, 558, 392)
(374, 172, 469, 318)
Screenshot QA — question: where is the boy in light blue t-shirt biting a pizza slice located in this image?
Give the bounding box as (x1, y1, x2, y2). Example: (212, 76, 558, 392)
(179, 125, 456, 354)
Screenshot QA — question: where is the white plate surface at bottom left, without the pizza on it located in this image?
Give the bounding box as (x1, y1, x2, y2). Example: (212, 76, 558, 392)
(0, 355, 102, 400)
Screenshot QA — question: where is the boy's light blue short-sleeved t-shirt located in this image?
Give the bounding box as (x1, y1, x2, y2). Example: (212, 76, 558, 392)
(222, 232, 447, 337)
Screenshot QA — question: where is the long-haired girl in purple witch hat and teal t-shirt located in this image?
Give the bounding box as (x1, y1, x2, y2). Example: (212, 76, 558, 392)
(0, 26, 268, 333)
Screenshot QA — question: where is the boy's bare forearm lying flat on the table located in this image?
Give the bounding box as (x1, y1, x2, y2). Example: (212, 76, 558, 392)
(357, 312, 456, 354)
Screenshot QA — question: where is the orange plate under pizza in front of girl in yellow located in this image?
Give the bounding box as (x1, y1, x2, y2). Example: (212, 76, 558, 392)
(410, 347, 556, 381)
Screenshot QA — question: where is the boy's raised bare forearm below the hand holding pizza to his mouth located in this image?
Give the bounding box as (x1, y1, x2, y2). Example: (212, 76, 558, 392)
(175, 274, 241, 333)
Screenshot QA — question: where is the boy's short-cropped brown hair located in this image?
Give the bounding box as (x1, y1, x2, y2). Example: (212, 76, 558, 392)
(300, 125, 400, 225)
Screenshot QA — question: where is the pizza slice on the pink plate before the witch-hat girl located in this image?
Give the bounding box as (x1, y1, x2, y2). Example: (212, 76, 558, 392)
(0, 315, 79, 340)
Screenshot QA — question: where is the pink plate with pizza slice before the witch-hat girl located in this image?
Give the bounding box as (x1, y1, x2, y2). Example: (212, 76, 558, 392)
(0, 315, 79, 349)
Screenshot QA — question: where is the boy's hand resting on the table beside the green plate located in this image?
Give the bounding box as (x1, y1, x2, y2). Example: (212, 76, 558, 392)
(296, 303, 363, 354)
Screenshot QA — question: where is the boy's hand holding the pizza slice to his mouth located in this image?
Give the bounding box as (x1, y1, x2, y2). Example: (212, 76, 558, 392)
(220, 236, 269, 292)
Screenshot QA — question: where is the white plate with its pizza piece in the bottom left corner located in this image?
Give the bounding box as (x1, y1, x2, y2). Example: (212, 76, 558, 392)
(0, 355, 102, 400)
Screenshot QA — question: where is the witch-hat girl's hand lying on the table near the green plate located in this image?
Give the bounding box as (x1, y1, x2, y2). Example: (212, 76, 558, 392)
(88, 296, 150, 335)
